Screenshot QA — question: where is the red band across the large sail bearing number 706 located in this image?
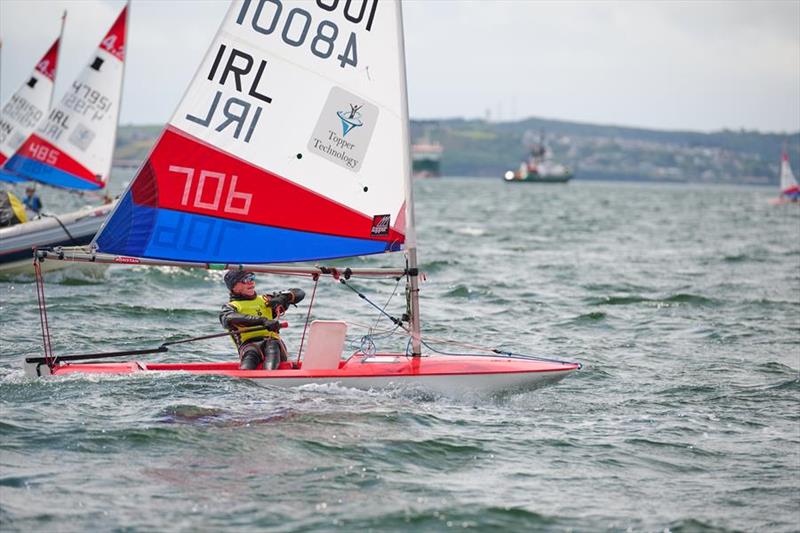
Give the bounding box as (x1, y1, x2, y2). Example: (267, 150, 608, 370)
(138, 127, 405, 243)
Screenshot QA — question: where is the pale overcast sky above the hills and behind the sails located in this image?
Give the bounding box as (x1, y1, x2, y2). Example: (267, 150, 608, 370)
(0, 0, 800, 132)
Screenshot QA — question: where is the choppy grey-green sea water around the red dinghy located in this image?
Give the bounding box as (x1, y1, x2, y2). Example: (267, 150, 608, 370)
(0, 179, 800, 531)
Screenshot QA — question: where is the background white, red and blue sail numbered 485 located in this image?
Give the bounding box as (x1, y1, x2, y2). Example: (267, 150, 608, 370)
(6, 5, 128, 189)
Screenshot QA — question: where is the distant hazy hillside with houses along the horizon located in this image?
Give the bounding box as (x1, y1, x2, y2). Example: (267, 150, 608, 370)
(115, 118, 800, 184)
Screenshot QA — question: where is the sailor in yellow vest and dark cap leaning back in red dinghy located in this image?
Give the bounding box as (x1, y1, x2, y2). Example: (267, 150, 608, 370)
(219, 270, 306, 370)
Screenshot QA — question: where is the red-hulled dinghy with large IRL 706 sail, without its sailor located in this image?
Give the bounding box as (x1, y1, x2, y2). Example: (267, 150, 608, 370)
(21, 0, 580, 393)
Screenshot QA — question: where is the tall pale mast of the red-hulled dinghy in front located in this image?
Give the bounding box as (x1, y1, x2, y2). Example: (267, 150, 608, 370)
(396, 0, 422, 357)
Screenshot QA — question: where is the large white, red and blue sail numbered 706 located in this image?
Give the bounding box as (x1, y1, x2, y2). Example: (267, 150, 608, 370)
(94, 0, 413, 264)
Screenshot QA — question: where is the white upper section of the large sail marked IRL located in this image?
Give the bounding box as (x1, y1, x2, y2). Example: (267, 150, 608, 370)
(170, 0, 405, 222)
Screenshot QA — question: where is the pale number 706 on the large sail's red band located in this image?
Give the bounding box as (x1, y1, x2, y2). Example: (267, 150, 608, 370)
(169, 165, 253, 215)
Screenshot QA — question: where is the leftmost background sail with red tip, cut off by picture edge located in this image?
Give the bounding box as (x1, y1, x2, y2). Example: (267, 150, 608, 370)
(0, 18, 66, 177)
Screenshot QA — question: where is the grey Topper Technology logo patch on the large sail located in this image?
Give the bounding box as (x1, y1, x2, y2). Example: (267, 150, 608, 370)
(308, 87, 378, 172)
